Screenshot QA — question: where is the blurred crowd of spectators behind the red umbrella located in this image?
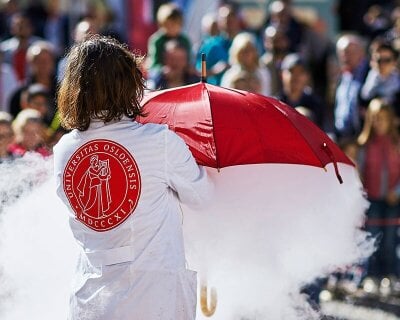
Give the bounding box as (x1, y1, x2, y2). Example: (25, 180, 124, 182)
(0, 0, 400, 290)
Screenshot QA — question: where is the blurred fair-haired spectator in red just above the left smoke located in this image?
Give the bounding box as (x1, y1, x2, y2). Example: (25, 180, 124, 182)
(9, 109, 50, 157)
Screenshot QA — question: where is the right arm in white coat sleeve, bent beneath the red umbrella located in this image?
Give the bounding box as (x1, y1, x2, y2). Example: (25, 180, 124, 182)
(165, 130, 213, 207)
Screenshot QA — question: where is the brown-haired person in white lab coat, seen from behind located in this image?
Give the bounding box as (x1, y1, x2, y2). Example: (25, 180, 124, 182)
(54, 36, 210, 320)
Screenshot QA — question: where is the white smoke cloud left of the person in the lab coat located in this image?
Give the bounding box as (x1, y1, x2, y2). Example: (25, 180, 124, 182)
(0, 154, 77, 320)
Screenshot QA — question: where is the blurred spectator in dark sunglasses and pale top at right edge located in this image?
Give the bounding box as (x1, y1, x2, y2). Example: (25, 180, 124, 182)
(361, 43, 400, 116)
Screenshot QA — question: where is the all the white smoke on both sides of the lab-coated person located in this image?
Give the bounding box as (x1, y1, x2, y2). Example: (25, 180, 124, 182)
(0, 159, 372, 320)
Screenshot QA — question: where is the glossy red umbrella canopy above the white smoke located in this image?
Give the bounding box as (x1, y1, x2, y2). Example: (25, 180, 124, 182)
(138, 82, 352, 180)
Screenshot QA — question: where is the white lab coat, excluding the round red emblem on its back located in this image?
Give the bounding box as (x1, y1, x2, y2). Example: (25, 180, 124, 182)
(54, 118, 211, 320)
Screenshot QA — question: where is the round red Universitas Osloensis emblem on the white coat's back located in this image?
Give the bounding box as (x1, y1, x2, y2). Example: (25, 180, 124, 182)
(63, 139, 141, 231)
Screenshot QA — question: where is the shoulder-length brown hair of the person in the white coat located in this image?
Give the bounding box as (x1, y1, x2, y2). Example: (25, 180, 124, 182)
(57, 36, 145, 131)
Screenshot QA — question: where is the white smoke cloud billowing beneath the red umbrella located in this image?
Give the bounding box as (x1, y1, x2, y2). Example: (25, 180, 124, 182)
(183, 164, 373, 320)
